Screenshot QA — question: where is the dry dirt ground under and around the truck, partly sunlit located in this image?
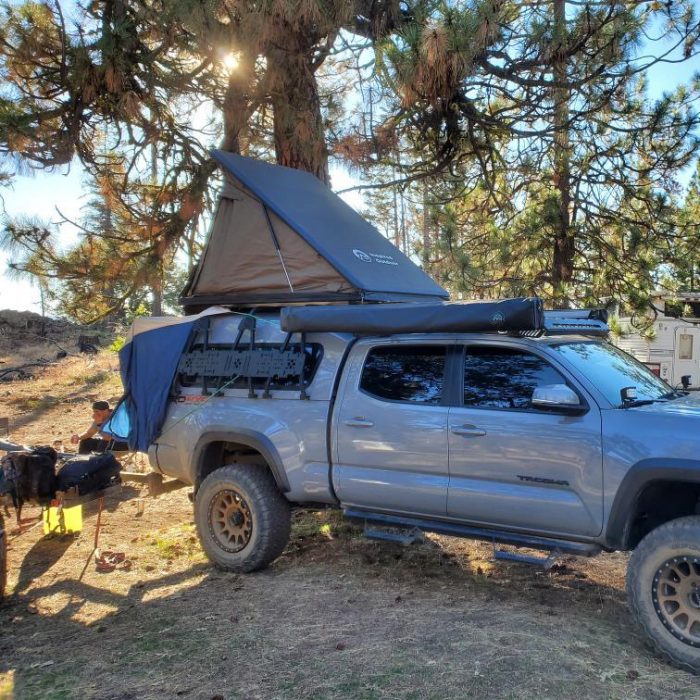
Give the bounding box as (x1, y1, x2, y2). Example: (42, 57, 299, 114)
(0, 353, 700, 700)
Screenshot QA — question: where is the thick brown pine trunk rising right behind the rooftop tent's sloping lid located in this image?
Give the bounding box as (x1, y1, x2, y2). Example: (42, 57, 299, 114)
(268, 39, 330, 184)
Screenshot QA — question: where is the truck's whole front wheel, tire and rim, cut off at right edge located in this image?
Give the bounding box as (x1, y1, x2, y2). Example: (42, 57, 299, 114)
(627, 516, 700, 673)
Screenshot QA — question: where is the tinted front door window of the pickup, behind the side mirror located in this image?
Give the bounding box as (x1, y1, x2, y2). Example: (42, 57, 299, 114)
(464, 345, 566, 409)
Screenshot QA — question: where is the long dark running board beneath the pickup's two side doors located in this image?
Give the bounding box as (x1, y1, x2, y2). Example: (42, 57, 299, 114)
(343, 508, 602, 557)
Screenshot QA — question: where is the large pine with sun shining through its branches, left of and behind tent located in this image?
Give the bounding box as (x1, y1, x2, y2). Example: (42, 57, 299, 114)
(0, 0, 412, 314)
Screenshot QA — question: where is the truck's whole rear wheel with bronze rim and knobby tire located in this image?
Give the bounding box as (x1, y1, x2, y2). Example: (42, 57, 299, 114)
(194, 464, 292, 572)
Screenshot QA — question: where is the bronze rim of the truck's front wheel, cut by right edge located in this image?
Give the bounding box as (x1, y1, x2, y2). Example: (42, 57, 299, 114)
(651, 556, 700, 647)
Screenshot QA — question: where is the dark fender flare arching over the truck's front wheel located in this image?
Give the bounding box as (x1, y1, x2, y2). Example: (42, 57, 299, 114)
(605, 458, 700, 551)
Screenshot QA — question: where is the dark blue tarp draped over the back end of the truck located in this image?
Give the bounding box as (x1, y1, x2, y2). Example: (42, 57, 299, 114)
(104, 316, 198, 452)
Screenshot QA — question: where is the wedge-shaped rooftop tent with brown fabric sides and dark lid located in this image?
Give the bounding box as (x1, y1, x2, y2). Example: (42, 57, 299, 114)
(181, 151, 449, 311)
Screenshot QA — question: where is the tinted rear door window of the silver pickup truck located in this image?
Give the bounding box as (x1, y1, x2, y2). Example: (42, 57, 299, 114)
(360, 345, 446, 404)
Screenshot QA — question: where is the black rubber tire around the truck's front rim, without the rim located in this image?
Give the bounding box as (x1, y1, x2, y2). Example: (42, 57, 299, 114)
(627, 516, 700, 674)
